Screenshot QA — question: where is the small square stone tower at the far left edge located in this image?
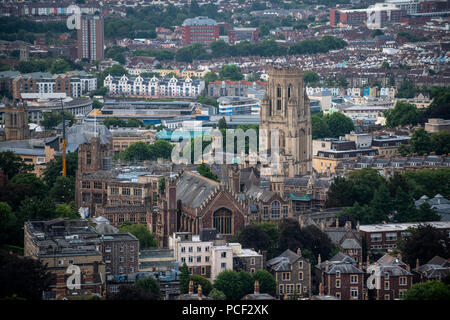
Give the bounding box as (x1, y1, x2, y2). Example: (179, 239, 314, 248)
(5, 102, 30, 140)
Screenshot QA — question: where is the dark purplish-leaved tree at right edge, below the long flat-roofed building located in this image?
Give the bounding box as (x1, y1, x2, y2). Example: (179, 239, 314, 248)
(399, 225, 450, 266)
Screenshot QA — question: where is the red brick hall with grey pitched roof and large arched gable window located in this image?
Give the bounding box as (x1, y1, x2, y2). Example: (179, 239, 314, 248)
(156, 170, 249, 247)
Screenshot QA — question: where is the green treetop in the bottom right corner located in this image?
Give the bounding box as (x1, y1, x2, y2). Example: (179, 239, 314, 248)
(403, 280, 450, 301)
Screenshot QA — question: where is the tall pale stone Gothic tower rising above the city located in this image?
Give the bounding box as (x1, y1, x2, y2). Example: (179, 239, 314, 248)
(260, 68, 312, 191)
